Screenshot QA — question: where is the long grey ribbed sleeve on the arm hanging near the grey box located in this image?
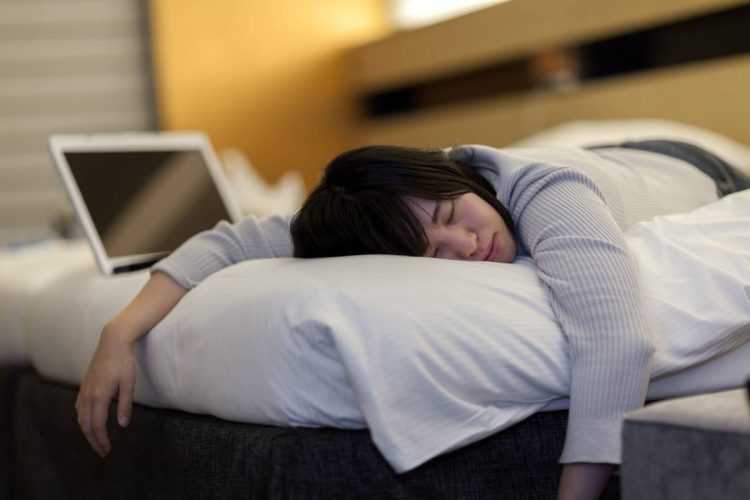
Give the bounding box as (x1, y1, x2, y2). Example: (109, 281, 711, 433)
(514, 169, 653, 463)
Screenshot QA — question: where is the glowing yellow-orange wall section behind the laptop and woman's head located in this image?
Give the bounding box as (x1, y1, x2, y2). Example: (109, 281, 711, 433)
(151, 0, 386, 185)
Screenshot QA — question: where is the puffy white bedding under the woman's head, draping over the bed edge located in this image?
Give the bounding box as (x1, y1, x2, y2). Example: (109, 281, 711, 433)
(138, 191, 750, 471)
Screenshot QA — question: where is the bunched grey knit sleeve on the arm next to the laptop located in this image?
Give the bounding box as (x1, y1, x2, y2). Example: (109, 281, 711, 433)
(151, 216, 292, 290)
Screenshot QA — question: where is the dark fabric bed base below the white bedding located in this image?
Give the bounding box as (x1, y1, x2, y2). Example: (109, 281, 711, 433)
(0, 368, 619, 500)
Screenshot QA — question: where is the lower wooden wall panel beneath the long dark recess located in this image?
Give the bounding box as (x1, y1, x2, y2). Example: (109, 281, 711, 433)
(360, 55, 750, 147)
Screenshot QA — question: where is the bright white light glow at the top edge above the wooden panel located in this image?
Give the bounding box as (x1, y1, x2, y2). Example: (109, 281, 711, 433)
(389, 0, 508, 29)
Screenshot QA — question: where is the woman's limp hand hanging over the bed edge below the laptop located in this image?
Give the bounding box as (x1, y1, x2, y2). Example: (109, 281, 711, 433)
(76, 322, 141, 457)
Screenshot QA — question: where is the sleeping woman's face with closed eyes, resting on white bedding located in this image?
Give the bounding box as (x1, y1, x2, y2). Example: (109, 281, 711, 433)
(408, 193, 516, 263)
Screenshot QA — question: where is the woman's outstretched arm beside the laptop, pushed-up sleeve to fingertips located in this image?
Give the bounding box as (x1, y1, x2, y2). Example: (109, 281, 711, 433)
(76, 216, 292, 456)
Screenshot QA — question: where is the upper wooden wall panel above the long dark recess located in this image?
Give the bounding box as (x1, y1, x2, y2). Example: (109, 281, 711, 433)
(355, 0, 748, 93)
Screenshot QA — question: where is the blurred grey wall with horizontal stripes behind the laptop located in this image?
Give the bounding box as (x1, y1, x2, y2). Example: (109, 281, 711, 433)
(0, 0, 157, 245)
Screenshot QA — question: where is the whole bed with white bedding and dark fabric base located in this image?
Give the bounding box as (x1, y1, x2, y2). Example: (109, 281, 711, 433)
(0, 123, 750, 498)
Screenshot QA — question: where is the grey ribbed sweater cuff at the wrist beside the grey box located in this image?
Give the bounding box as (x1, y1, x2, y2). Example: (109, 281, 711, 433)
(560, 418, 622, 464)
